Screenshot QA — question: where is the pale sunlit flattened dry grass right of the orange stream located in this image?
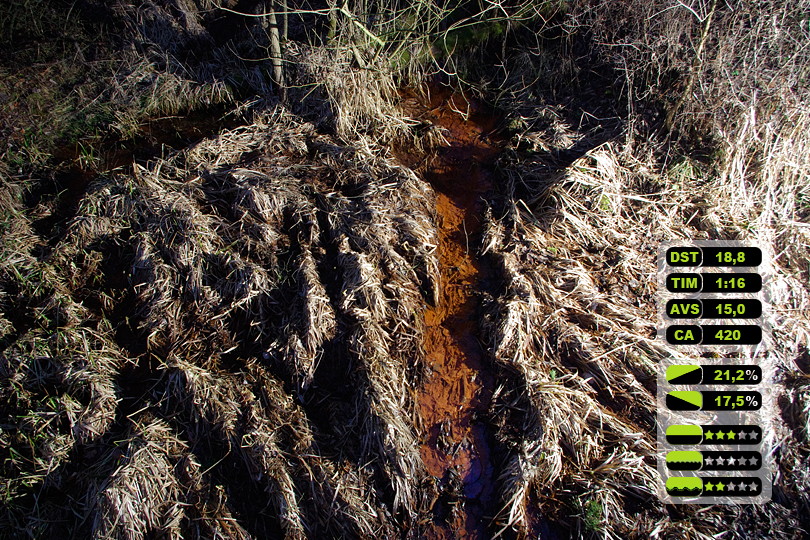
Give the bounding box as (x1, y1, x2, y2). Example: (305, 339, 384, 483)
(483, 96, 808, 538)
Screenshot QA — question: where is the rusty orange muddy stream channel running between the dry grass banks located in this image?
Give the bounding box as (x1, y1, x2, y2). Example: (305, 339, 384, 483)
(396, 88, 499, 538)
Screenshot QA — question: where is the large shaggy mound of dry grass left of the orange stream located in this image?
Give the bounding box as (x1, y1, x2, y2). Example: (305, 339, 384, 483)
(3, 102, 438, 538)
